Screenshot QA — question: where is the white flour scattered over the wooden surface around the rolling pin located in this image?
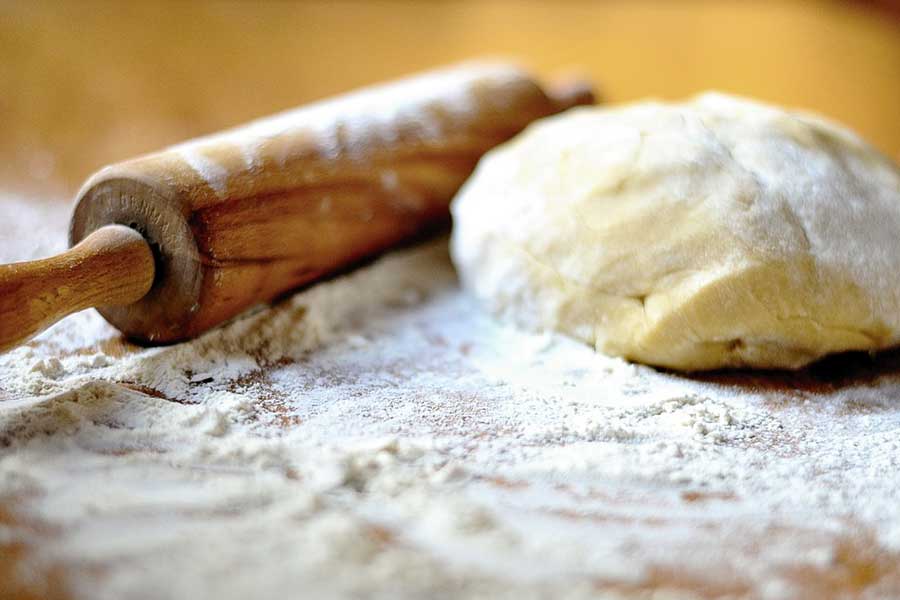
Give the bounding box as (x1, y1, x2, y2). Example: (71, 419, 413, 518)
(0, 198, 900, 598)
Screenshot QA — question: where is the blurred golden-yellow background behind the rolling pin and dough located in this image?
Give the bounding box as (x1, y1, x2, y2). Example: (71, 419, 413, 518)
(0, 0, 900, 199)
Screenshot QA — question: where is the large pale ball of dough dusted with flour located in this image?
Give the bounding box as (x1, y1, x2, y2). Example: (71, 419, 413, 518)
(451, 94, 900, 370)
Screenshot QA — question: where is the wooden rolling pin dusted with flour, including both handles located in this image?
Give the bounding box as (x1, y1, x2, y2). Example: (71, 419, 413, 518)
(0, 64, 593, 351)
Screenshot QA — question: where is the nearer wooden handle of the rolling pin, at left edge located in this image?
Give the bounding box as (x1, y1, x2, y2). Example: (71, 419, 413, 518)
(0, 225, 156, 352)
